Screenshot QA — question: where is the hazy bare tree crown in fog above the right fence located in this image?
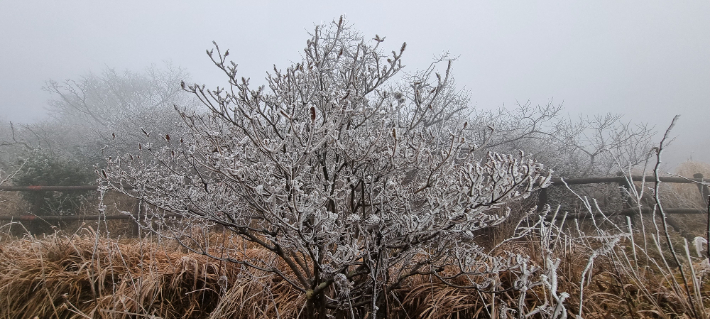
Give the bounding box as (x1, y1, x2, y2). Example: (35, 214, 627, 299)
(472, 101, 655, 177)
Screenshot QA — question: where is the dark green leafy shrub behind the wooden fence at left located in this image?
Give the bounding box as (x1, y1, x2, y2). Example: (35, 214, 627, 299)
(13, 152, 95, 216)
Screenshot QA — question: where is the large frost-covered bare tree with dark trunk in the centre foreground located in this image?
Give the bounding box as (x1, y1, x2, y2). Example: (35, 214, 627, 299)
(101, 19, 550, 318)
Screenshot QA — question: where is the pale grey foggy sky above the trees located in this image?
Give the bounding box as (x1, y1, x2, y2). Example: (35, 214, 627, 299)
(0, 0, 710, 168)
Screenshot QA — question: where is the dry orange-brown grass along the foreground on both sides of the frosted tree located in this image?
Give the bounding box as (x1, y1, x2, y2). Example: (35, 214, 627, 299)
(0, 225, 710, 319)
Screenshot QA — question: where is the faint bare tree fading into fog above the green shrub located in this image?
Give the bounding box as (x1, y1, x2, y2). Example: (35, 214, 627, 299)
(38, 64, 194, 162)
